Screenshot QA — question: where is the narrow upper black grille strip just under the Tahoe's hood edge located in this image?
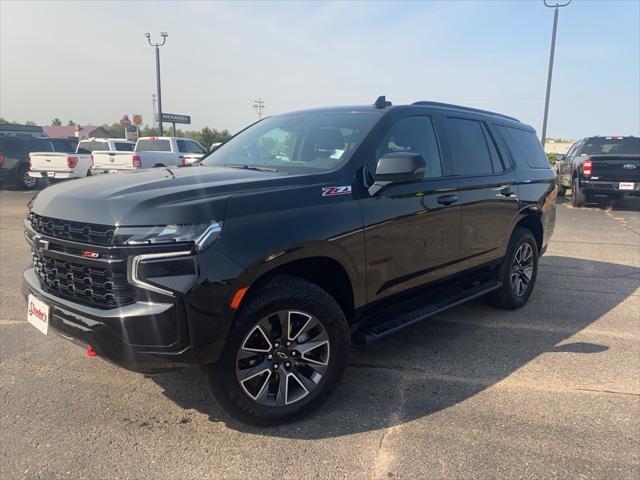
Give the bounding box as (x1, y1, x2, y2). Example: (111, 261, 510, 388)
(28, 212, 115, 246)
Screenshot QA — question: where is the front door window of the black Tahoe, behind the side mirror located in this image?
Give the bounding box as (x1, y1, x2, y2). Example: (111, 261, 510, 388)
(376, 117, 442, 178)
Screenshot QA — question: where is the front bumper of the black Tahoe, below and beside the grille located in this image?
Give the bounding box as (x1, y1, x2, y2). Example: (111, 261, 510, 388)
(22, 227, 240, 373)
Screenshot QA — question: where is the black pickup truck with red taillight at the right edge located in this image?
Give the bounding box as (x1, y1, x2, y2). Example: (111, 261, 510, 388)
(557, 137, 640, 207)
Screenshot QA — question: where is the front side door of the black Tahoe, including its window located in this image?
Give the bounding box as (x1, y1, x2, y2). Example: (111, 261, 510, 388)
(361, 115, 460, 301)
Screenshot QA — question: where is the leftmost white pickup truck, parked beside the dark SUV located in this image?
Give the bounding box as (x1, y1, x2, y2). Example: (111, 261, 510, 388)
(29, 138, 135, 180)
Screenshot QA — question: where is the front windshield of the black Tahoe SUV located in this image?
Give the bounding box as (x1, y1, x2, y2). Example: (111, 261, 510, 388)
(202, 112, 379, 172)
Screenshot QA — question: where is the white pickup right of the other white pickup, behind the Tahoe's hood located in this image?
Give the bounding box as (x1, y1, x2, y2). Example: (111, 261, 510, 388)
(92, 137, 207, 174)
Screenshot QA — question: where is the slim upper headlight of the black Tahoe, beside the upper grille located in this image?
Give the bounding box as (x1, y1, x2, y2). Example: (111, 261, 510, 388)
(114, 222, 222, 252)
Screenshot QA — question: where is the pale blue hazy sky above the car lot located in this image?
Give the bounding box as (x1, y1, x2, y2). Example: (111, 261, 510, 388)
(0, 0, 640, 139)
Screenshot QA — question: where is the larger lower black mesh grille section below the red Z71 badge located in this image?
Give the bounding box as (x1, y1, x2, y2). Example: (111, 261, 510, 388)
(32, 249, 134, 308)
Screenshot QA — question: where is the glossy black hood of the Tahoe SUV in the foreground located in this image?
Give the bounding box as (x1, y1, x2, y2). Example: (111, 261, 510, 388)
(31, 167, 291, 226)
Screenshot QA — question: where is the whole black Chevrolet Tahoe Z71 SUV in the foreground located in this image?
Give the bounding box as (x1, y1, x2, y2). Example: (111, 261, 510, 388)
(23, 97, 557, 425)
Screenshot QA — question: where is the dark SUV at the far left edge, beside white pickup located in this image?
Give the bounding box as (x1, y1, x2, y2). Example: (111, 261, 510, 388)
(0, 135, 76, 190)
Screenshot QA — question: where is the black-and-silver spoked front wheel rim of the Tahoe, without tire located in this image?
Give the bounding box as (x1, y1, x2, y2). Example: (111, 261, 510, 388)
(236, 310, 331, 407)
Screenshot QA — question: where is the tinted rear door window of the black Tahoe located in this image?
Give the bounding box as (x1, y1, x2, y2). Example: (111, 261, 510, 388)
(447, 118, 493, 175)
